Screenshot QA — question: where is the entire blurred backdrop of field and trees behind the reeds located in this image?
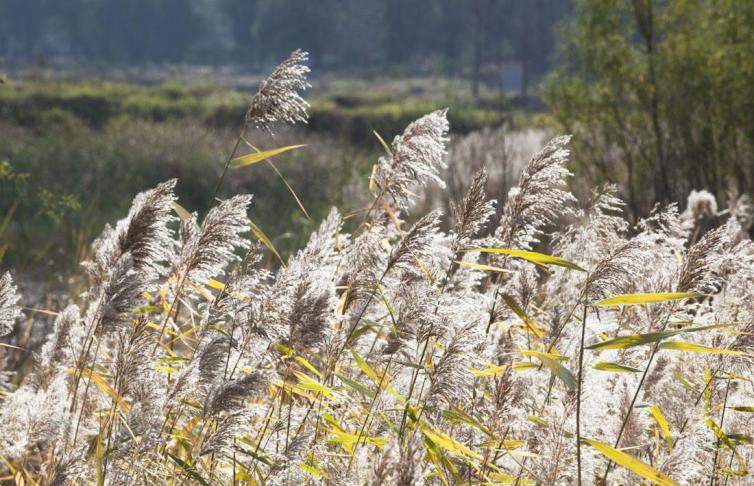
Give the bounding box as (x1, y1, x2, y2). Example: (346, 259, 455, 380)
(0, 0, 754, 279)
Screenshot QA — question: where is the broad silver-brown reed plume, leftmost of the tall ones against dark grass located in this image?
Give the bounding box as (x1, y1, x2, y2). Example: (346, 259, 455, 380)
(82, 179, 176, 283)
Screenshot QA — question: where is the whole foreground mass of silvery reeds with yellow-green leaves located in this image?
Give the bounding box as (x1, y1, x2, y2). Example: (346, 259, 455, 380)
(0, 52, 754, 485)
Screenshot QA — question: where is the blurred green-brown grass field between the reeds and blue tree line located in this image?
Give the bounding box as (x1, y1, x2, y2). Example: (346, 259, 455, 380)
(0, 76, 542, 274)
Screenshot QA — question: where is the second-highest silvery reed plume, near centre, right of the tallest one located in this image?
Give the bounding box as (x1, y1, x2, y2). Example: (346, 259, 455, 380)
(374, 109, 449, 209)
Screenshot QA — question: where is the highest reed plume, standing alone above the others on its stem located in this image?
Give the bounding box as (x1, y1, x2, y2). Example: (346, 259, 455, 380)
(246, 49, 309, 132)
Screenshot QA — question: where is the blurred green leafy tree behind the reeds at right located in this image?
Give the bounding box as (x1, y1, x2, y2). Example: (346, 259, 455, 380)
(544, 0, 754, 214)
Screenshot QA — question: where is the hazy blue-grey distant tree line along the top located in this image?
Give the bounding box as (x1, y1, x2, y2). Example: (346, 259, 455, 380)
(0, 0, 570, 91)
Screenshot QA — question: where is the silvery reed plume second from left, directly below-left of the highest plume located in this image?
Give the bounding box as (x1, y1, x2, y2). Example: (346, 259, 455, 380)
(174, 195, 251, 285)
